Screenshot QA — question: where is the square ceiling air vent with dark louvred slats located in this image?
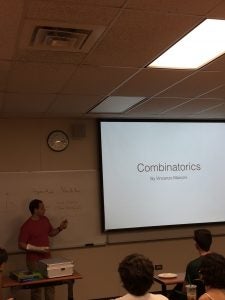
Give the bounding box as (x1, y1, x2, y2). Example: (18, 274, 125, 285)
(30, 26, 104, 52)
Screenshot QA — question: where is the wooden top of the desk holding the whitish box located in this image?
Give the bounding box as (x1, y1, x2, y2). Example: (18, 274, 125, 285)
(2, 271, 82, 288)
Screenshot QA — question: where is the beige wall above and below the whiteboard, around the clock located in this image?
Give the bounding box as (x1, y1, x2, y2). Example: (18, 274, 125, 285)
(0, 119, 225, 300)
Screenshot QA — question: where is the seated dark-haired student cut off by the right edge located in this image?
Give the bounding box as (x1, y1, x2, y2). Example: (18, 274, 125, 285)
(199, 253, 225, 300)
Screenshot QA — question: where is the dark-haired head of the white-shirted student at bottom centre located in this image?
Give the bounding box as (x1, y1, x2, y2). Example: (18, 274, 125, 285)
(118, 253, 154, 296)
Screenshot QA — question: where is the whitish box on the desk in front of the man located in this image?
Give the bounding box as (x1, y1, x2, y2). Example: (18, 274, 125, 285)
(39, 258, 74, 278)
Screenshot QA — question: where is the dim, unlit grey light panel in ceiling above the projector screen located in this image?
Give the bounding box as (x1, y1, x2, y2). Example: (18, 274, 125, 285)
(90, 96, 145, 113)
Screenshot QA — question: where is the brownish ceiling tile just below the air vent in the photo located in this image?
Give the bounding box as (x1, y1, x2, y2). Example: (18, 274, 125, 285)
(8, 62, 74, 93)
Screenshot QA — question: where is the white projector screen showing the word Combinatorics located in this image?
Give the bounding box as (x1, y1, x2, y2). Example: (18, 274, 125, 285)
(100, 120, 225, 230)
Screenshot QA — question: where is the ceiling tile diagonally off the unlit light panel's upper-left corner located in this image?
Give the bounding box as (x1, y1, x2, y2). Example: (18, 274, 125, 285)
(63, 66, 136, 95)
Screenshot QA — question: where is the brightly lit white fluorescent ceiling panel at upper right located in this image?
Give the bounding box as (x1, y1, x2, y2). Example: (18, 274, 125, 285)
(148, 19, 225, 69)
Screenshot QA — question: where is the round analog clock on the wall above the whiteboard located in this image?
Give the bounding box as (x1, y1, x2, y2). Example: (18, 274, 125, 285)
(47, 130, 69, 152)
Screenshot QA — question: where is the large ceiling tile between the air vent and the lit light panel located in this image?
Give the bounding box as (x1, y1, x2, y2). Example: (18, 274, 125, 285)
(85, 10, 202, 67)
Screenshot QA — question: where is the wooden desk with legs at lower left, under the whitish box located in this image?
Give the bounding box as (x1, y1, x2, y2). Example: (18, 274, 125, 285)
(2, 271, 82, 300)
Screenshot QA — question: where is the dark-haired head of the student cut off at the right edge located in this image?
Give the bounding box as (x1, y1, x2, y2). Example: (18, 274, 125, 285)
(199, 253, 225, 289)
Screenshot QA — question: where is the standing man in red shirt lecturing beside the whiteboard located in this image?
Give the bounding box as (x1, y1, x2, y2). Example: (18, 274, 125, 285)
(19, 199, 68, 300)
